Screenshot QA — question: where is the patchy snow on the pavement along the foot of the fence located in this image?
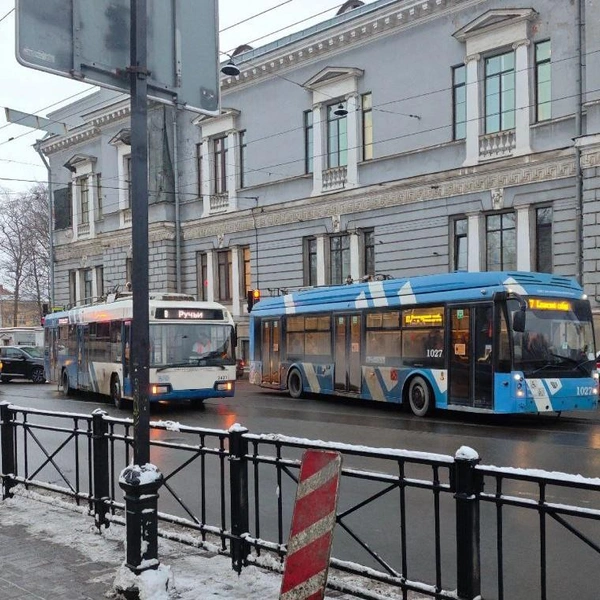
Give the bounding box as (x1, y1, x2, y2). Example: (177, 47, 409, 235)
(0, 489, 424, 600)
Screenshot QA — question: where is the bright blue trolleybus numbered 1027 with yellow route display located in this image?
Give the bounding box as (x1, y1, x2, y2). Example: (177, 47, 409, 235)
(250, 272, 598, 416)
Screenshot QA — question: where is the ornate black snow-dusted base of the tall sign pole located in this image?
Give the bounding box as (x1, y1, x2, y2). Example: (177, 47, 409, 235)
(119, 464, 163, 575)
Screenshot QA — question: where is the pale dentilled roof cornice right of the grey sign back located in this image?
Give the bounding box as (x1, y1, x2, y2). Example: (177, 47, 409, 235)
(221, 0, 481, 93)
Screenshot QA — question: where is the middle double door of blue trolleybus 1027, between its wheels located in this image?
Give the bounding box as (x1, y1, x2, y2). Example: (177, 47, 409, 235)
(334, 314, 361, 393)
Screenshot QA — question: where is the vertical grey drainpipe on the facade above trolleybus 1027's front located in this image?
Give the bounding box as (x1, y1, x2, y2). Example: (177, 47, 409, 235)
(575, 0, 585, 285)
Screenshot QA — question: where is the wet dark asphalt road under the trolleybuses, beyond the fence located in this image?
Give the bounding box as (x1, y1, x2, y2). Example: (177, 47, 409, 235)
(0, 380, 600, 600)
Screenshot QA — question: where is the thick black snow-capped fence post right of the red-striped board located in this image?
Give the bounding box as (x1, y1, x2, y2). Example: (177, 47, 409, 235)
(454, 446, 483, 600)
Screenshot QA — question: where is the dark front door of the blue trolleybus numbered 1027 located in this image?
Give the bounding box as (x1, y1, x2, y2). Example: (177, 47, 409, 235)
(448, 304, 494, 409)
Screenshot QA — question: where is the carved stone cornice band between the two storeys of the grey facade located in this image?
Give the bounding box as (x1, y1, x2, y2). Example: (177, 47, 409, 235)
(182, 150, 600, 240)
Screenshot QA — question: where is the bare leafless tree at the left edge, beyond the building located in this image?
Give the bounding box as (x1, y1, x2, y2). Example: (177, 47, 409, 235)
(0, 184, 50, 323)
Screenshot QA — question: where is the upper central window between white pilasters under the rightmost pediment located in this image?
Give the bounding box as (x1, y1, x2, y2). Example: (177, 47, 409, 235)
(485, 51, 515, 133)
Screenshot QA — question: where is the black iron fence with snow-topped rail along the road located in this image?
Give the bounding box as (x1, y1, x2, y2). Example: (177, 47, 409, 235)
(0, 403, 600, 600)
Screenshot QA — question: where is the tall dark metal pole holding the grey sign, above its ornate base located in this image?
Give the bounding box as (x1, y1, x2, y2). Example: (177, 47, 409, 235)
(130, 0, 150, 466)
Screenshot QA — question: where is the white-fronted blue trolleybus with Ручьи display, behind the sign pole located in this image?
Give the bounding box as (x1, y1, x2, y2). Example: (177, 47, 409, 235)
(44, 294, 236, 408)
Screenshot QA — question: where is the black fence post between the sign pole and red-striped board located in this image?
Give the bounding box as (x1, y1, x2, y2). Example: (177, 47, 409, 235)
(229, 424, 250, 573)
